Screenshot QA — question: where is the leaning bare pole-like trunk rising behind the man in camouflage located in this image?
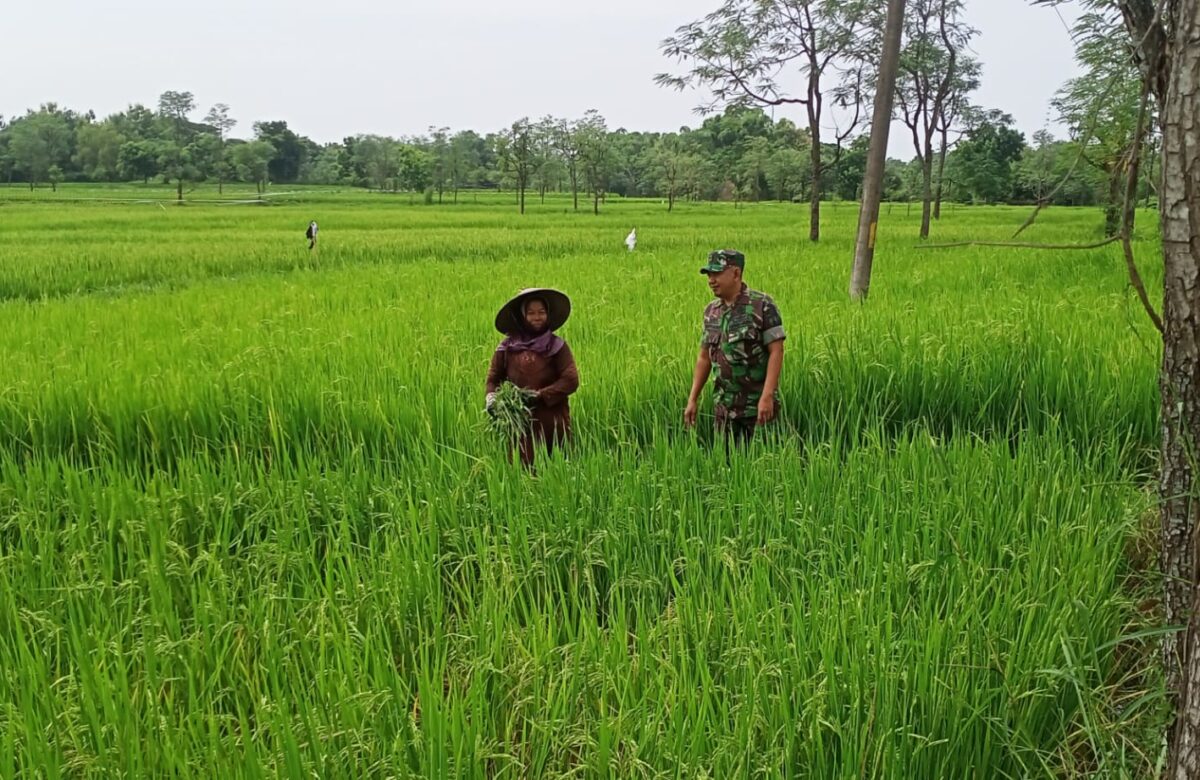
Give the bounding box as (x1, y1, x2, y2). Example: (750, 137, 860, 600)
(850, 0, 905, 300)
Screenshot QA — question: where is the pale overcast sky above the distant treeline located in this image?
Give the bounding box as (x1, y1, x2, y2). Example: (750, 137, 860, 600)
(0, 0, 1078, 158)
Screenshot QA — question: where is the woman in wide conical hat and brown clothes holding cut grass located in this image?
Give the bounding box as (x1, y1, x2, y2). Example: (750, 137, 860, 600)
(487, 287, 580, 467)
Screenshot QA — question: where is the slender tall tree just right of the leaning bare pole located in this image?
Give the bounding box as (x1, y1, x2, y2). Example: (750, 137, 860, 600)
(895, 0, 976, 239)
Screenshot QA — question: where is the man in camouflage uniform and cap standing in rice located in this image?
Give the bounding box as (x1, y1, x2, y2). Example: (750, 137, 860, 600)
(683, 250, 786, 444)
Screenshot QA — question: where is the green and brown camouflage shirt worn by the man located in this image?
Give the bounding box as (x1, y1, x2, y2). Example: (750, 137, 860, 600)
(701, 284, 786, 422)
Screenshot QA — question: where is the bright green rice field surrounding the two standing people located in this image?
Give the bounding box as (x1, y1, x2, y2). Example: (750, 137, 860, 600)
(0, 187, 1163, 778)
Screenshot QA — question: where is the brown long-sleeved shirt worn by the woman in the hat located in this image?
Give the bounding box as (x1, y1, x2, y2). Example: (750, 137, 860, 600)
(487, 344, 580, 436)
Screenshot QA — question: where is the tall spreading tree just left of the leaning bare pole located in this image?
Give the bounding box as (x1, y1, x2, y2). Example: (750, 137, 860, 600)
(656, 0, 875, 241)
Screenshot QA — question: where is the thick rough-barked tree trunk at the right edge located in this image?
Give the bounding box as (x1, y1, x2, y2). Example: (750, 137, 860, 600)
(1159, 0, 1200, 780)
